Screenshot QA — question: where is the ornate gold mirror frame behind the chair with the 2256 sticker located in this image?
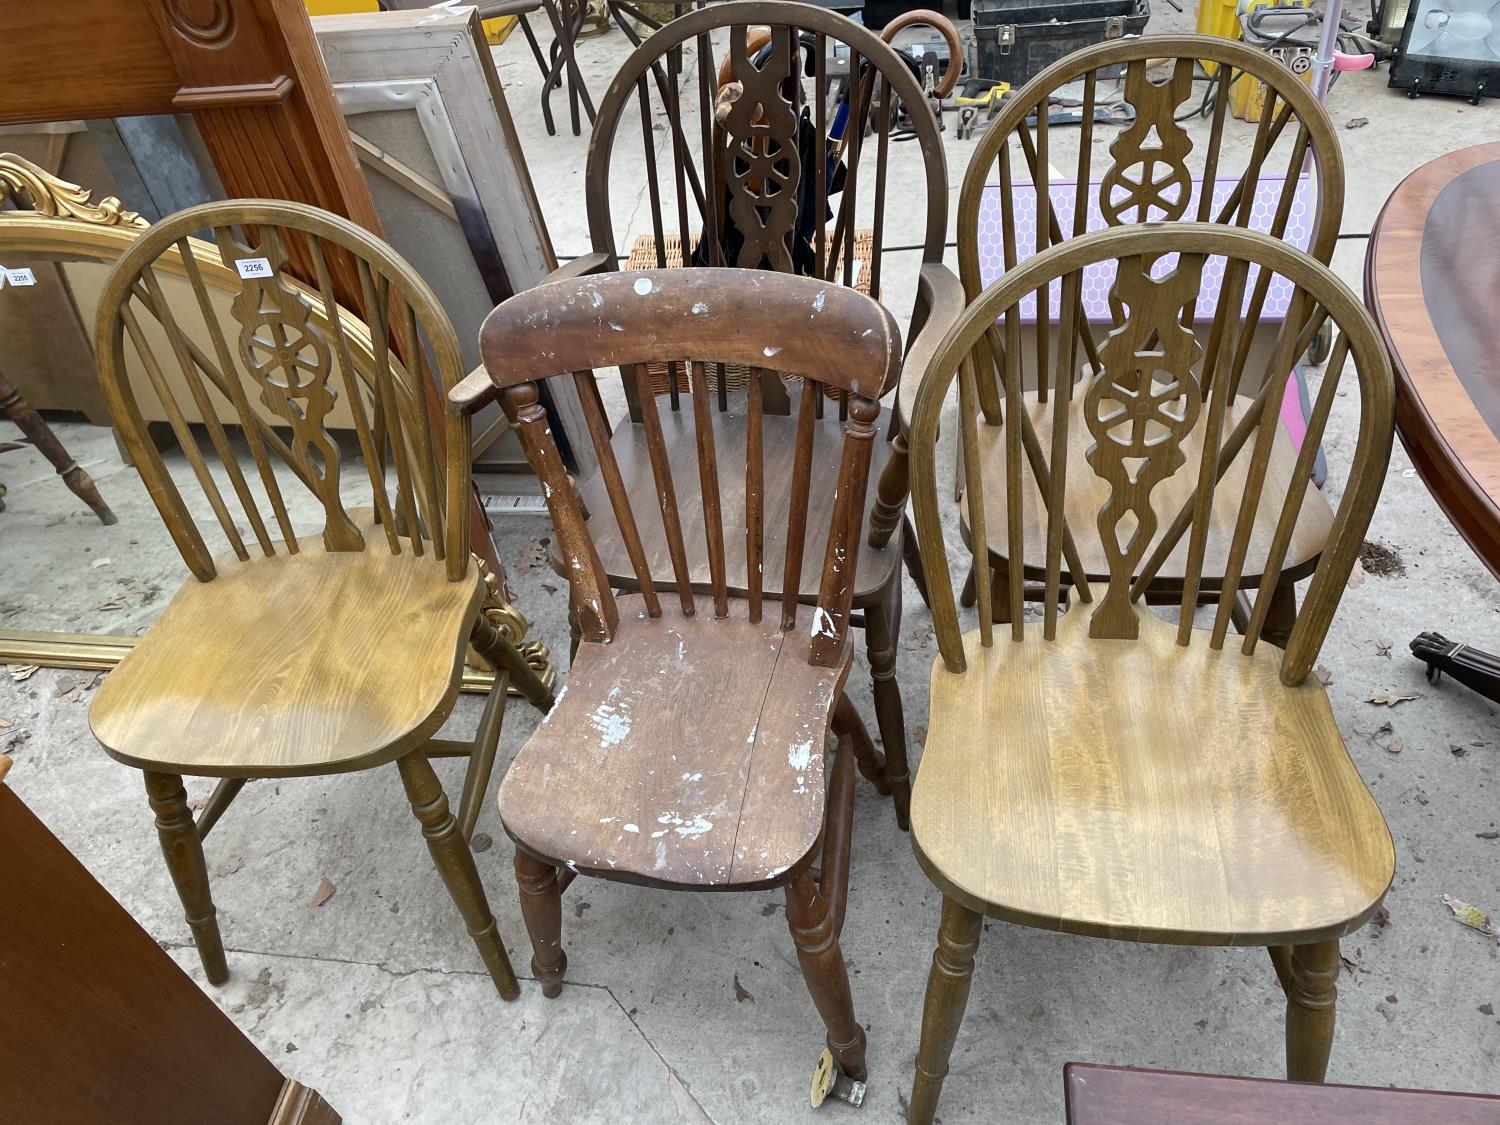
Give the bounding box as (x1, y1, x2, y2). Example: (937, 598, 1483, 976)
(0, 153, 557, 695)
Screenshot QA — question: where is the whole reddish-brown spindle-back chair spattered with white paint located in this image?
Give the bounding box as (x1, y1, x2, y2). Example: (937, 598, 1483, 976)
(452, 269, 900, 1104)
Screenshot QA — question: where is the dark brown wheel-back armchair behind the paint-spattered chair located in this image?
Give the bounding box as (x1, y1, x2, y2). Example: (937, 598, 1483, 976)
(552, 0, 963, 827)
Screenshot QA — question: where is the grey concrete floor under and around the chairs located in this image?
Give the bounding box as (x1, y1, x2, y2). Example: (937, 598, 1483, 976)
(0, 8, 1500, 1125)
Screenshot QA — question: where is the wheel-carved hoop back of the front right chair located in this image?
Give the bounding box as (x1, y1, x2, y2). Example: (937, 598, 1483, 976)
(912, 222, 1394, 684)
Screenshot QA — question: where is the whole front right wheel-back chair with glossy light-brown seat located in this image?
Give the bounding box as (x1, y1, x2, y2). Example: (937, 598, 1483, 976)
(911, 224, 1395, 1122)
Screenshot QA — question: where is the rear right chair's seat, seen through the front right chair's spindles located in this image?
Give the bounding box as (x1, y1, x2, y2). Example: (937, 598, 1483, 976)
(962, 392, 1334, 591)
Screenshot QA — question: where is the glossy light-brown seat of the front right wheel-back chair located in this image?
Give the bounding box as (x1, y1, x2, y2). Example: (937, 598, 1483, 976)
(912, 612, 1395, 945)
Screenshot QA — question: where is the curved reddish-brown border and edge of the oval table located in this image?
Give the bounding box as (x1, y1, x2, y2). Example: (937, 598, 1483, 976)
(1365, 143, 1500, 578)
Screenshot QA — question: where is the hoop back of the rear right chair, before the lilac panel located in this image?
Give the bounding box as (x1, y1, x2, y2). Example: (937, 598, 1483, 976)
(957, 35, 1344, 420)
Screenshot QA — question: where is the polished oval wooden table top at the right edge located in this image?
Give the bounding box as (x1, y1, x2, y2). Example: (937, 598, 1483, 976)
(1365, 143, 1500, 576)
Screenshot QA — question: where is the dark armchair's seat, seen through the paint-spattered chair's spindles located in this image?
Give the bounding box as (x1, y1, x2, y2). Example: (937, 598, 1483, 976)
(567, 396, 902, 608)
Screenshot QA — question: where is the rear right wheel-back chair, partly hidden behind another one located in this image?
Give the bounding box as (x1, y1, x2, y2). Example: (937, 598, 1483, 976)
(948, 35, 1344, 644)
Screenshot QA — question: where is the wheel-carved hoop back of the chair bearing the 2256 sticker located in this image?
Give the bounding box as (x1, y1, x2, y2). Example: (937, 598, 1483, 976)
(95, 200, 470, 581)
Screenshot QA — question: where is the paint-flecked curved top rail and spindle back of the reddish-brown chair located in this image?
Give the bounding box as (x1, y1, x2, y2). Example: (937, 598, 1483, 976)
(452, 269, 902, 666)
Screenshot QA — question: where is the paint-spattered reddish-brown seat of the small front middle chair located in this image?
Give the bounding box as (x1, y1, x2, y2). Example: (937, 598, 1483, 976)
(500, 596, 849, 890)
